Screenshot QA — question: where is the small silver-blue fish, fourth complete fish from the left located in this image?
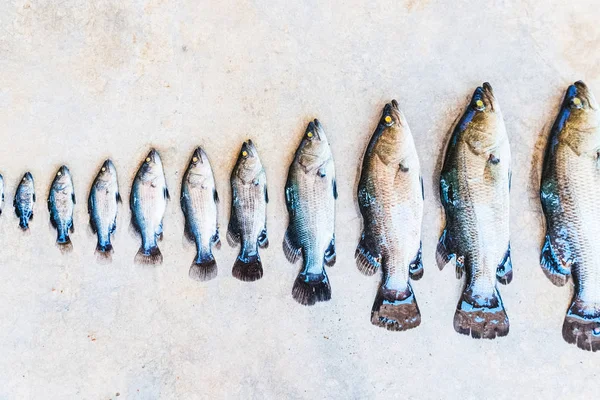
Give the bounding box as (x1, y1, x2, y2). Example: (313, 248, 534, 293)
(129, 149, 170, 265)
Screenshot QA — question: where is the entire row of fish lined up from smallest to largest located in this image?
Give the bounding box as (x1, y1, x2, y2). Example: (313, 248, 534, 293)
(0, 81, 600, 351)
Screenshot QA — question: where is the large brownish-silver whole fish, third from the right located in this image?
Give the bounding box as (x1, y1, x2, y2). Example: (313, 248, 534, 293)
(355, 100, 424, 331)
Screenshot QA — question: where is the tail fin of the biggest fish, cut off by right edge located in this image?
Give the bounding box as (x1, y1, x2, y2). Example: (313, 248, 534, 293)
(563, 294, 600, 351)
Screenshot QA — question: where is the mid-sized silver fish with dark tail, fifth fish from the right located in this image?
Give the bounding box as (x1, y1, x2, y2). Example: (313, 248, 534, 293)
(227, 140, 269, 282)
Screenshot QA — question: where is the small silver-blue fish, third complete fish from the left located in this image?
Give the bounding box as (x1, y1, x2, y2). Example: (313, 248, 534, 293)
(88, 160, 122, 260)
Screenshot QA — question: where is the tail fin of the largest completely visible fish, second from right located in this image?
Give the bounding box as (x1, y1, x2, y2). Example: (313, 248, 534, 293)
(454, 287, 509, 339)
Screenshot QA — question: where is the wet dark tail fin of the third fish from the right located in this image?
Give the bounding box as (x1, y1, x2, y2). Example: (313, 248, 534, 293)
(371, 284, 421, 331)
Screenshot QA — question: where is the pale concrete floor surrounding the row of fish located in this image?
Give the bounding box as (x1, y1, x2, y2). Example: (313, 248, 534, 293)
(0, 0, 600, 399)
